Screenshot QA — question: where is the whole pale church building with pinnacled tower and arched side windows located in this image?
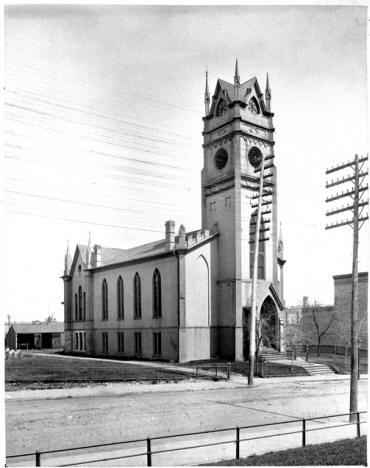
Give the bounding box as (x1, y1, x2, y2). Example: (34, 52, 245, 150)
(62, 63, 285, 362)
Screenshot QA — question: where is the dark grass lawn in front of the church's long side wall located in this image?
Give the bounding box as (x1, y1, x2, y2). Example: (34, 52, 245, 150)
(5, 353, 192, 391)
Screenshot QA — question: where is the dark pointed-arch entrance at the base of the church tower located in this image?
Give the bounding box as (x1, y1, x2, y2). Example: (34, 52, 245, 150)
(258, 296, 280, 350)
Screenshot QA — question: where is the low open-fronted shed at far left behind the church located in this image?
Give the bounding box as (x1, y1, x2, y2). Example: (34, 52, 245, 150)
(5, 321, 64, 349)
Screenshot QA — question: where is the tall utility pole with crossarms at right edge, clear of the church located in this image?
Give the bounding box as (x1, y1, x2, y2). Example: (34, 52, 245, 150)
(325, 154, 369, 421)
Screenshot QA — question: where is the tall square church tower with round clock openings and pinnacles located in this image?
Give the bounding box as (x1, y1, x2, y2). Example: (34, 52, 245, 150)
(202, 61, 283, 360)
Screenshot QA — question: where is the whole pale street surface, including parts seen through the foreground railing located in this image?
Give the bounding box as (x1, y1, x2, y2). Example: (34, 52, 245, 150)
(6, 370, 367, 466)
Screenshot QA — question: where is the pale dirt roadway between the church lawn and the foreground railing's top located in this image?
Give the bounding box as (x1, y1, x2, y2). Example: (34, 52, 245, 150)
(6, 378, 367, 464)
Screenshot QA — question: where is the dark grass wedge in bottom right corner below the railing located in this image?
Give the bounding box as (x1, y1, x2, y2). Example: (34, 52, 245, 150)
(207, 436, 367, 466)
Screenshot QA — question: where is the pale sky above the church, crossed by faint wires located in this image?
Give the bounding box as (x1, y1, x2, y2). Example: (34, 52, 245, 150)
(2, 5, 369, 321)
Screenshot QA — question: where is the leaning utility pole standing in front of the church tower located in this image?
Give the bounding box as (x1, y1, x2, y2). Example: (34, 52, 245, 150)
(248, 154, 274, 385)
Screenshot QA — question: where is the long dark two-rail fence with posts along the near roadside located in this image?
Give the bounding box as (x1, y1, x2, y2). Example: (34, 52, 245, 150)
(6, 411, 367, 466)
